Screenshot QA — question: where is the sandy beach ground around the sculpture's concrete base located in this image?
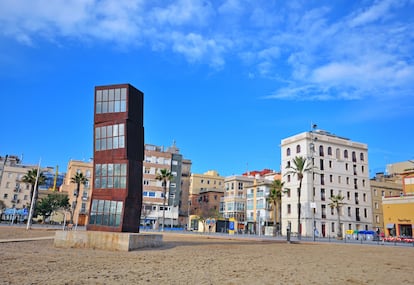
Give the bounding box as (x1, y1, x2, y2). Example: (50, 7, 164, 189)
(0, 226, 414, 284)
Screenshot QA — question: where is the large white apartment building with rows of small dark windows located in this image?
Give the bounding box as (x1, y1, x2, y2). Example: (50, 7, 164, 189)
(281, 128, 372, 237)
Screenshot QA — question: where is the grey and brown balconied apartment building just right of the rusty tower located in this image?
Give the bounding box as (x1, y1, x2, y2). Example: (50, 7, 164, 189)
(141, 142, 191, 227)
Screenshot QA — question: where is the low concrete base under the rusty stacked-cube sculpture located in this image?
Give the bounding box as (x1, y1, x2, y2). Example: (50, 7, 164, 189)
(54, 231, 162, 251)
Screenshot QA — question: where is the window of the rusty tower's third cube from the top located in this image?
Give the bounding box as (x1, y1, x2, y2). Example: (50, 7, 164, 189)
(95, 163, 127, 189)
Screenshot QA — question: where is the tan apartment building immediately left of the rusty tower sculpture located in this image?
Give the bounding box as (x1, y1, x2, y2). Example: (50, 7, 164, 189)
(59, 160, 93, 226)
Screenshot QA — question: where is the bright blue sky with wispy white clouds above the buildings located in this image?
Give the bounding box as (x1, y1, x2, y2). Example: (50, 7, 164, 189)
(0, 0, 414, 176)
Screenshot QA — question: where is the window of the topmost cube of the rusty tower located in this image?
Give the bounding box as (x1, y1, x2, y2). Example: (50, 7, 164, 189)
(95, 88, 127, 114)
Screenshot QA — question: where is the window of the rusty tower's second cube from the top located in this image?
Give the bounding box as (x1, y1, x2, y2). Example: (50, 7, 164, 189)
(95, 124, 125, 151)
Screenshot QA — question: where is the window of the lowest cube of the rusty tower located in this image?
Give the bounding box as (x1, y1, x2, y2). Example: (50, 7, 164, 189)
(89, 200, 123, 227)
